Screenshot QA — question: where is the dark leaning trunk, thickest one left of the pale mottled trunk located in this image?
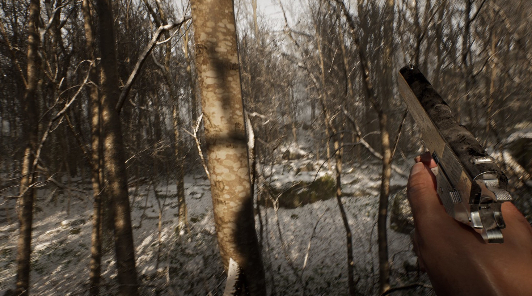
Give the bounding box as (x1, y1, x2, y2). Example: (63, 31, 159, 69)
(97, 0, 138, 296)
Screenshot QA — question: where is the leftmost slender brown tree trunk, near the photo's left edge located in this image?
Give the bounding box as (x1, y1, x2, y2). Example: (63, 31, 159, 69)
(15, 0, 40, 295)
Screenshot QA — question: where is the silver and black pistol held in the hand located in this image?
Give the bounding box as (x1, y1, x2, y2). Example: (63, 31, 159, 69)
(398, 66, 512, 243)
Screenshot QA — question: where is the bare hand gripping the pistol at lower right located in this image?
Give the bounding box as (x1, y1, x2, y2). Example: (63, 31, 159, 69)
(407, 153, 532, 296)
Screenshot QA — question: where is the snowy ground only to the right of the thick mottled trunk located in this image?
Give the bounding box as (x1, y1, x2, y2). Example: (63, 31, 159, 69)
(257, 161, 429, 295)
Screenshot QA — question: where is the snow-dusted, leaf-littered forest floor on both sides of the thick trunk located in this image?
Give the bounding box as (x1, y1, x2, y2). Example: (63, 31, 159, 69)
(0, 159, 430, 295)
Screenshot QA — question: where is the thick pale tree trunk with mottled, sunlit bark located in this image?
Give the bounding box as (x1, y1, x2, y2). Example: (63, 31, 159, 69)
(192, 0, 266, 295)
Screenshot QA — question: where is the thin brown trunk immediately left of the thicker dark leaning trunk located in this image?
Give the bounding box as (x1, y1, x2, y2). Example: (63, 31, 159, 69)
(82, 0, 103, 295)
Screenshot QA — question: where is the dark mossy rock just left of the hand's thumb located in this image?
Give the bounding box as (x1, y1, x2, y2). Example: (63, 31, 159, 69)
(390, 187, 414, 234)
